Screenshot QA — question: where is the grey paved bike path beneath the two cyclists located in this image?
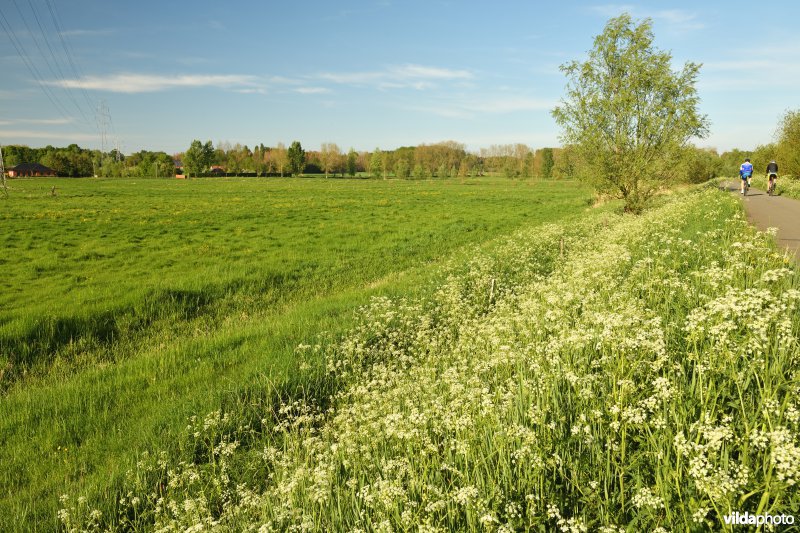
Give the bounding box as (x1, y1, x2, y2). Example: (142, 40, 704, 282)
(725, 182, 800, 262)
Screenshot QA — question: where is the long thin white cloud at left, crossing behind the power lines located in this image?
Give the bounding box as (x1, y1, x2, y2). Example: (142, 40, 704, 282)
(49, 74, 257, 93)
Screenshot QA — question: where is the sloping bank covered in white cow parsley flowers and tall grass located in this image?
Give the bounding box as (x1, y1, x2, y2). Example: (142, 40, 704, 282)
(61, 183, 800, 532)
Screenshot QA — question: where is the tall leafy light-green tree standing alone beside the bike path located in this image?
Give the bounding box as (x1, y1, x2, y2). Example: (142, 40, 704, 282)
(553, 14, 708, 213)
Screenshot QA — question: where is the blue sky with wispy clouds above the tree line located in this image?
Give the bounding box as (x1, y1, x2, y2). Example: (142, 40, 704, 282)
(0, 0, 800, 153)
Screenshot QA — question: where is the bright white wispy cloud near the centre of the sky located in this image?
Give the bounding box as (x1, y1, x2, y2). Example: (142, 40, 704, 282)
(317, 64, 474, 90)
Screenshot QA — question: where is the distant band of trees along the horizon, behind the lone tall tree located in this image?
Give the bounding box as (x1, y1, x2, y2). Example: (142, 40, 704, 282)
(3, 110, 800, 183)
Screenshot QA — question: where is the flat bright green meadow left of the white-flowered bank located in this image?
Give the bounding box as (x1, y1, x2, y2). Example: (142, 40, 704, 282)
(0, 179, 589, 531)
